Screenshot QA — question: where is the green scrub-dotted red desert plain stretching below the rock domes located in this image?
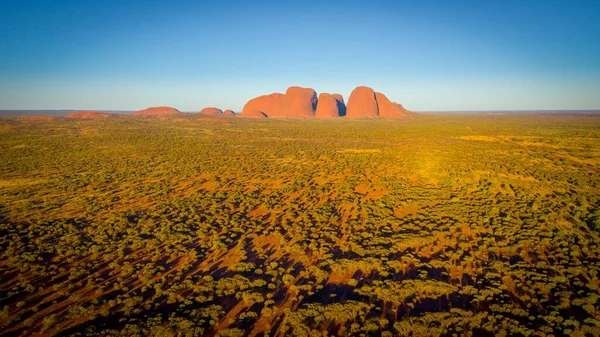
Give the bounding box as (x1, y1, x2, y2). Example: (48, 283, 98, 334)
(0, 114, 600, 336)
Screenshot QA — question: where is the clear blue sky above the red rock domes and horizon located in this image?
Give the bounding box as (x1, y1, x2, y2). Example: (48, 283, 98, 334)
(0, 0, 600, 111)
